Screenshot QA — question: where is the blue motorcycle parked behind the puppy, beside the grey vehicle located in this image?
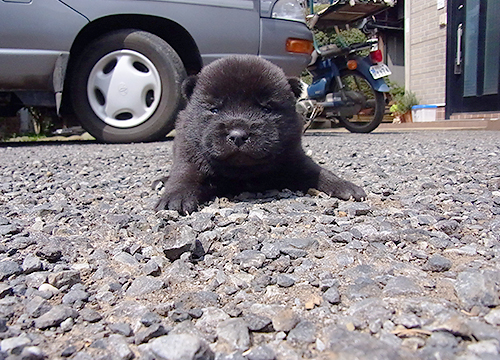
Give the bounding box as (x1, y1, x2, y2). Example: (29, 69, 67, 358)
(297, 2, 391, 133)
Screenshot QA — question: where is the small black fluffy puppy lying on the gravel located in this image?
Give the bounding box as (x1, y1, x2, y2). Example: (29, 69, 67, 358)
(156, 56, 366, 213)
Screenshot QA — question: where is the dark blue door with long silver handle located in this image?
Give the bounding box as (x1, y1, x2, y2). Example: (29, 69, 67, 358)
(446, 0, 500, 118)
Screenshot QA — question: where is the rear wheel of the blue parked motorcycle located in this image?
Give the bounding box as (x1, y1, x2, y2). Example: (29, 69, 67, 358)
(333, 70, 385, 133)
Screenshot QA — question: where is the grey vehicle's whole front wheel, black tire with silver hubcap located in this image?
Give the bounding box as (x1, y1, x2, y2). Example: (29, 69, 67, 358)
(71, 29, 186, 143)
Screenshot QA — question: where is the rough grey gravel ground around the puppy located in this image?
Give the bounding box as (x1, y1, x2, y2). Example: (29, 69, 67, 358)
(0, 131, 500, 360)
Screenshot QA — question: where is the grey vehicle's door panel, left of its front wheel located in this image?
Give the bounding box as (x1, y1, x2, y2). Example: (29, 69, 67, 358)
(0, 0, 88, 91)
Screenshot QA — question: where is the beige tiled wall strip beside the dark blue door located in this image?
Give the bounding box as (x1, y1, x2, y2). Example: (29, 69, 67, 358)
(405, 0, 446, 104)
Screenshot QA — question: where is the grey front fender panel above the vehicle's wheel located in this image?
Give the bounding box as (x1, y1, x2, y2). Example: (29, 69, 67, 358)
(60, 0, 260, 65)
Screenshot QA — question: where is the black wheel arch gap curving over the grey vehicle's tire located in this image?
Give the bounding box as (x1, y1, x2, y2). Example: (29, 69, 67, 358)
(60, 14, 203, 115)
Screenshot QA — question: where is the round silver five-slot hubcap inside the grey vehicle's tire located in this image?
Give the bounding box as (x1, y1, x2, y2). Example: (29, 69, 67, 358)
(87, 50, 161, 128)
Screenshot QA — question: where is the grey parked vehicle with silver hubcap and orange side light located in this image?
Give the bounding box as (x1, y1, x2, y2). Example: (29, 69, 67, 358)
(0, 0, 312, 142)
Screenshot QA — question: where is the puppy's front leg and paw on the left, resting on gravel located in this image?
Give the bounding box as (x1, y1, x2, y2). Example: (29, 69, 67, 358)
(155, 163, 210, 215)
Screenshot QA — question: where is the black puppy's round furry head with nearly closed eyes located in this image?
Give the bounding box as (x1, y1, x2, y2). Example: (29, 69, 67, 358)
(178, 56, 302, 167)
